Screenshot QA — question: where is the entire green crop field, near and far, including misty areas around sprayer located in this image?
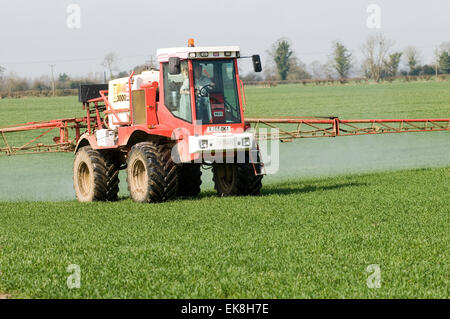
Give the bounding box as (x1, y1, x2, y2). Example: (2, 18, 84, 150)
(0, 82, 450, 298)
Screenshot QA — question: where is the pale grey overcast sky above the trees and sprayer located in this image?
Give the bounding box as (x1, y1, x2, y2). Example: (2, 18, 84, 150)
(0, 0, 450, 77)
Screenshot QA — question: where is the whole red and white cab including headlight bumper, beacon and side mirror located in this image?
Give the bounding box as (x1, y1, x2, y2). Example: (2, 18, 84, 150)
(157, 41, 261, 159)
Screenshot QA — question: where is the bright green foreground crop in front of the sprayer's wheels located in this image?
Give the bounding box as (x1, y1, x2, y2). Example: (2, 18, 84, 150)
(0, 168, 450, 298)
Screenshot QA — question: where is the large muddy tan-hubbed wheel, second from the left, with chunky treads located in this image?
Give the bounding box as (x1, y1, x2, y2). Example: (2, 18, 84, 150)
(127, 142, 178, 203)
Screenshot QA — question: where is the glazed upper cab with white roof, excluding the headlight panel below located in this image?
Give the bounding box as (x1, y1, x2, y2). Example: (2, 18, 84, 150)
(158, 46, 243, 125)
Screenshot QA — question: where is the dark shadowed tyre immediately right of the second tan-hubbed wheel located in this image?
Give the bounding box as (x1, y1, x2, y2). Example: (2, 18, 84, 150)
(177, 163, 202, 196)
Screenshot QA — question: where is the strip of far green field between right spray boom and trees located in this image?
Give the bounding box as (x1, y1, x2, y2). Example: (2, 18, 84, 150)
(246, 82, 450, 119)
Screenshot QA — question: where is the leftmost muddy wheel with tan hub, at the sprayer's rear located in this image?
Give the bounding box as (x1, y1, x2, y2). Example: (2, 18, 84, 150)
(73, 146, 119, 202)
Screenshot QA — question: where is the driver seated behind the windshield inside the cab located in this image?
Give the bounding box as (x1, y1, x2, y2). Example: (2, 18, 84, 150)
(194, 63, 215, 123)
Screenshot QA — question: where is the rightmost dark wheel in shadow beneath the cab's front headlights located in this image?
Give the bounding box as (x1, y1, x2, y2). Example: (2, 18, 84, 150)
(213, 164, 262, 196)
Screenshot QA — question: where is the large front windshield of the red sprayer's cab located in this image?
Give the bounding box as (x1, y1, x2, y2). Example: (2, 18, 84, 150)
(193, 60, 241, 124)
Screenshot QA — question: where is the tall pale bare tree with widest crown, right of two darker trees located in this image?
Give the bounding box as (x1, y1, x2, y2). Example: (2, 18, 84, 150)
(361, 33, 393, 82)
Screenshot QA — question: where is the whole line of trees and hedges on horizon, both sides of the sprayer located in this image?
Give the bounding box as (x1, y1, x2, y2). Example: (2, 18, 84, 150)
(0, 33, 450, 97)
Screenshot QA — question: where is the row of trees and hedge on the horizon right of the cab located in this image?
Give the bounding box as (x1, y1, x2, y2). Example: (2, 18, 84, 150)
(243, 34, 450, 82)
